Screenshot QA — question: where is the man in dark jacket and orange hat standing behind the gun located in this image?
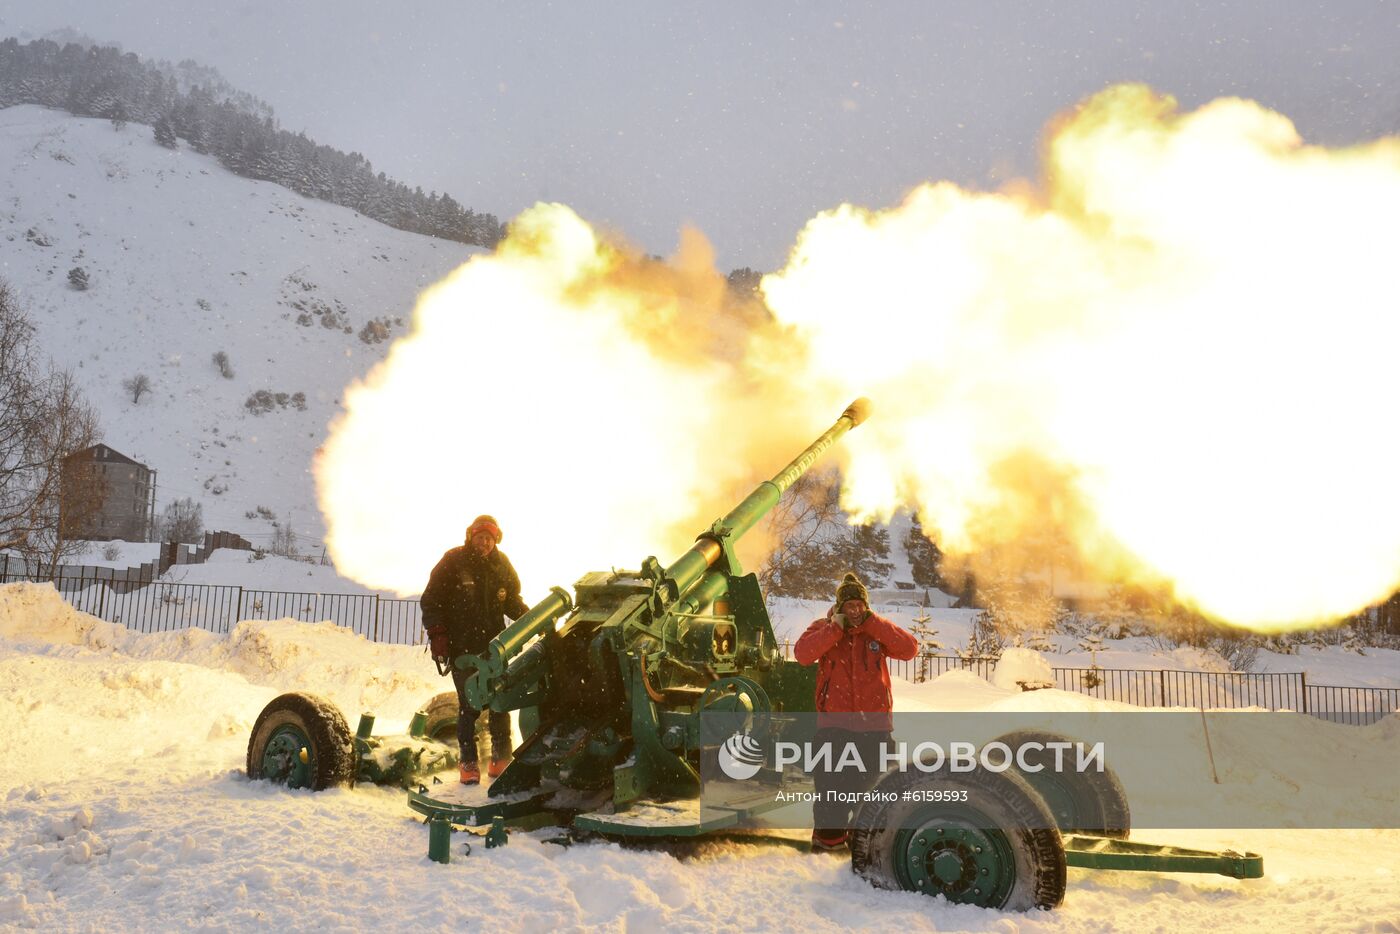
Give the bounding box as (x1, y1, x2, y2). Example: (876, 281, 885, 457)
(419, 515, 529, 784)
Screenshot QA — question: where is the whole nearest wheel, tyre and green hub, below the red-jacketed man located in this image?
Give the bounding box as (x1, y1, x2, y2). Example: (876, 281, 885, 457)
(851, 769, 1065, 912)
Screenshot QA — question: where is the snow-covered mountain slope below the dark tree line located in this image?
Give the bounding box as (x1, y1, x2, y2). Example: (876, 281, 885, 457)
(0, 106, 480, 542)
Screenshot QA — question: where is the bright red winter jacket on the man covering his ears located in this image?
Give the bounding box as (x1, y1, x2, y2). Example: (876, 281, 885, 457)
(792, 613, 918, 731)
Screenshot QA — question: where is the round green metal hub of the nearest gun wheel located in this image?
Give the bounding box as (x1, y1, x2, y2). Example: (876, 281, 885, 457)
(895, 807, 1016, 907)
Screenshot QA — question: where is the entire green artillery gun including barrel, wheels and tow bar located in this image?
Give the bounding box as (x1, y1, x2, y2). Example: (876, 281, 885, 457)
(248, 399, 1263, 910)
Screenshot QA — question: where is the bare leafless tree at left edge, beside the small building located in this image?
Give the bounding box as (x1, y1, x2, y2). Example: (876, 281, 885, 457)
(0, 281, 102, 573)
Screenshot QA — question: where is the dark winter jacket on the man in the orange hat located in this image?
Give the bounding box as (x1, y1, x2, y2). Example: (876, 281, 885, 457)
(419, 545, 529, 657)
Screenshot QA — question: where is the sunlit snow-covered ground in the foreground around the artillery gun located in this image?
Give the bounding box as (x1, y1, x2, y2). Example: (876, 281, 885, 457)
(0, 584, 1400, 933)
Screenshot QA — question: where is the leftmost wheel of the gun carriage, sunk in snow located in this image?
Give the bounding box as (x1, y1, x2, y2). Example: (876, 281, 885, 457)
(248, 693, 354, 791)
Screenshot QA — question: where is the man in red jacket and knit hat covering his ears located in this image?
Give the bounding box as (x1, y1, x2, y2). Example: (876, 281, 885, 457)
(792, 574, 918, 851)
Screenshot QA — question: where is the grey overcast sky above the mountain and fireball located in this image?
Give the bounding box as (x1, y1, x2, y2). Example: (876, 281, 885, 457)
(0, 0, 1400, 269)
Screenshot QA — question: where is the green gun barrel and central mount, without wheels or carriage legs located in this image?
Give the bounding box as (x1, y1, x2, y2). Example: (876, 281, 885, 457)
(442, 399, 868, 812)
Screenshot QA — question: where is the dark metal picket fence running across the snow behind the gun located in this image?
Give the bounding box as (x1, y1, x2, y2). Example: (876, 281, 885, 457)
(10, 574, 1400, 725)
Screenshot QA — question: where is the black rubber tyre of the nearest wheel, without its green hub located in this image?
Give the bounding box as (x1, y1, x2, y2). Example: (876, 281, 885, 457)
(850, 766, 1065, 912)
